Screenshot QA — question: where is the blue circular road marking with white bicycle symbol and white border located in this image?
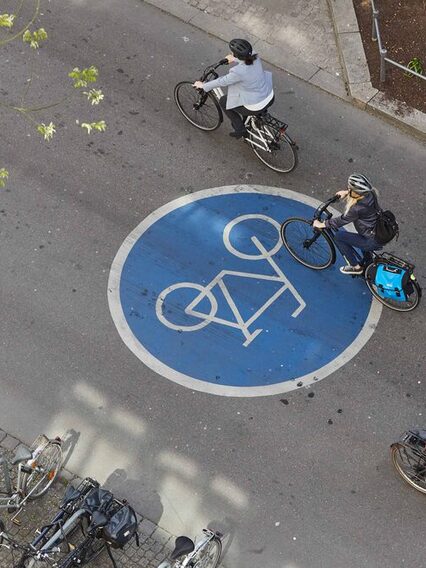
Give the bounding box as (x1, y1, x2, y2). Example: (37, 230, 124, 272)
(109, 186, 381, 396)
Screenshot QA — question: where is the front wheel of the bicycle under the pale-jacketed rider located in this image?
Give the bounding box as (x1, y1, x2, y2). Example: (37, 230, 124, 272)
(173, 81, 223, 132)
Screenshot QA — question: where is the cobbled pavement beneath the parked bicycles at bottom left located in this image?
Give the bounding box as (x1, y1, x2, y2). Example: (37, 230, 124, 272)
(0, 430, 174, 568)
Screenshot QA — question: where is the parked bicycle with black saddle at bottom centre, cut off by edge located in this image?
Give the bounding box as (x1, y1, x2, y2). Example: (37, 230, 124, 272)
(158, 529, 222, 568)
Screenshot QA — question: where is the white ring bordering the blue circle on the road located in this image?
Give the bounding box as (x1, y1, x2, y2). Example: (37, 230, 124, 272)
(108, 185, 382, 397)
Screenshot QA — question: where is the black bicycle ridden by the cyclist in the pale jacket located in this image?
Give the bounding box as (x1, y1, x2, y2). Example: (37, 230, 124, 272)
(174, 59, 298, 173)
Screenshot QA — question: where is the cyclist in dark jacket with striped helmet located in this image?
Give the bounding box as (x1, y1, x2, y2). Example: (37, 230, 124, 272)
(314, 174, 383, 274)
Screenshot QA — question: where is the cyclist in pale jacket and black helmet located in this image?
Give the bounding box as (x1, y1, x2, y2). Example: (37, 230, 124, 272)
(194, 39, 274, 138)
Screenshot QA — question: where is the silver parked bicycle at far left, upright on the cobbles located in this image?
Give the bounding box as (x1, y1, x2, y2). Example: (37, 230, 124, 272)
(0, 434, 63, 524)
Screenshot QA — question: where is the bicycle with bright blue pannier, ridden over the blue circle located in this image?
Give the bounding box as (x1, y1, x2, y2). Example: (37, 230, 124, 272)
(280, 196, 422, 312)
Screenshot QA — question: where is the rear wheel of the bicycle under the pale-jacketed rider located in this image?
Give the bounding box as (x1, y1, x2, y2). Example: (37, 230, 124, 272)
(249, 126, 298, 174)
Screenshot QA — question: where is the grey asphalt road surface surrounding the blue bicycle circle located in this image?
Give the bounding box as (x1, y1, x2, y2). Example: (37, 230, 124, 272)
(0, 0, 426, 568)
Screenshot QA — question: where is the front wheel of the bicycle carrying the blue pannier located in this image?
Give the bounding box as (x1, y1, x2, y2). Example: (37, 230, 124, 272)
(280, 217, 336, 270)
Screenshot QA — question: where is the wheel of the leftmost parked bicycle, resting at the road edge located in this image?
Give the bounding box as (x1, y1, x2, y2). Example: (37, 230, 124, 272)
(24, 440, 63, 500)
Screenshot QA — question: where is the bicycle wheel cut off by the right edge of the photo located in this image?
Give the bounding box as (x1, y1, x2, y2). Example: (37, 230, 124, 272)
(391, 428, 426, 494)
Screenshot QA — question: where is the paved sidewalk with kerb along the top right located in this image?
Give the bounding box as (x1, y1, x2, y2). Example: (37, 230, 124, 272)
(144, 0, 426, 137)
